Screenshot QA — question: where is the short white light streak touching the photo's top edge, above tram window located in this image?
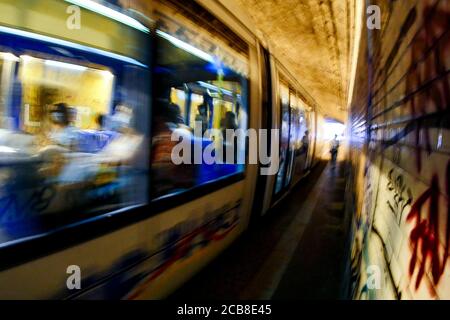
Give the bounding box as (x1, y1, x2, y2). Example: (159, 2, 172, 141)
(65, 0, 150, 33)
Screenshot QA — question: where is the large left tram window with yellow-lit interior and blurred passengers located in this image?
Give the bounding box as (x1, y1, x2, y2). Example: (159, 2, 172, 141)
(0, 45, 149, 236)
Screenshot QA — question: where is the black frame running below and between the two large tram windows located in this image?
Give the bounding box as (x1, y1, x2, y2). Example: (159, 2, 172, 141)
(0, 29, 252, 272)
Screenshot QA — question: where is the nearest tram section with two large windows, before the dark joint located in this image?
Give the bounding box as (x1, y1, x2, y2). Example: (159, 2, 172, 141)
(0, 0, 256, 299)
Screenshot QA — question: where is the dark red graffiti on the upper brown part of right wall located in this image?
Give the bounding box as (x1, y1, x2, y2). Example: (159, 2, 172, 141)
(406, 0, 450, 172)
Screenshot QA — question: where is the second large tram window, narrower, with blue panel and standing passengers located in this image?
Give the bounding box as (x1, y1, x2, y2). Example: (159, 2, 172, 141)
(151, 31, 247, 198)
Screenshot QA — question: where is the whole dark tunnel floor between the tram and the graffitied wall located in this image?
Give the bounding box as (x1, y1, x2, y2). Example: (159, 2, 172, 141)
(169, 162, 348, 300)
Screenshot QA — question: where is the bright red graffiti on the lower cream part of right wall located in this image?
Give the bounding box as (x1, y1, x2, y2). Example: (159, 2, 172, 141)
(407, 161, 450, 290)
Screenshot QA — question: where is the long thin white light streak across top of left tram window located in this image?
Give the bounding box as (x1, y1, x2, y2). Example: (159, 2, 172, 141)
(0, 26, 147, 68)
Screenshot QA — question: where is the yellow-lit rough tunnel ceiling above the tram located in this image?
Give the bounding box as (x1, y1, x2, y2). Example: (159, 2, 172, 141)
(236, 0, 354, 121)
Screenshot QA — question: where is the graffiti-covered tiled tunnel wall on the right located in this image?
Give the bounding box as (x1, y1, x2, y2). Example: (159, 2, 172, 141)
(347, 0, 450, 299)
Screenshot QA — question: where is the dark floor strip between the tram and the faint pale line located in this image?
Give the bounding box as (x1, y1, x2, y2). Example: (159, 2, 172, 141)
(169, 161, 327, 300)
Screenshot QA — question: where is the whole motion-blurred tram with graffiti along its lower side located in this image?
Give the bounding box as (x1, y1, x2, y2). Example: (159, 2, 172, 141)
(0, 0, 324, 299)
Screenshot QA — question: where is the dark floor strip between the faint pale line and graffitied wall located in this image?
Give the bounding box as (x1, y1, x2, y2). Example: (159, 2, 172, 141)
(273, 162, 347, 300)
